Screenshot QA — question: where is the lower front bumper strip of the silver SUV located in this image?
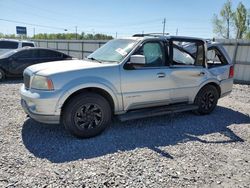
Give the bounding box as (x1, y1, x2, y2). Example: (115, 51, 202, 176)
(21, 99, 60, 124)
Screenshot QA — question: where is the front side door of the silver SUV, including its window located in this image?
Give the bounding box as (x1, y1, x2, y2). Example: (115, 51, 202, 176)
(121, 41, 172, 110)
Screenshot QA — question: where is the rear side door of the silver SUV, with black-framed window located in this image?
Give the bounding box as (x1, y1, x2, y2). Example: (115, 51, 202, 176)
(170, 38, 208, 103)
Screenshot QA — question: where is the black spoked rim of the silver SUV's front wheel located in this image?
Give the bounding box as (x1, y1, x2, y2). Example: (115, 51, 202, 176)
(74, 104, 103, 130)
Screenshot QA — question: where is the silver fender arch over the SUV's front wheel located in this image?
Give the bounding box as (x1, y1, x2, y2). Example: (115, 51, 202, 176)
(56, 77, 122, 114)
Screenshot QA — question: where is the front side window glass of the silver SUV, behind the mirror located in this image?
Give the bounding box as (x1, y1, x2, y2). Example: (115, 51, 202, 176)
(134, 42, 164, 67)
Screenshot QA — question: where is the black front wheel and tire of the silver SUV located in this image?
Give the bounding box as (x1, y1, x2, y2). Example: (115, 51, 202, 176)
(62, 92, 111, 138)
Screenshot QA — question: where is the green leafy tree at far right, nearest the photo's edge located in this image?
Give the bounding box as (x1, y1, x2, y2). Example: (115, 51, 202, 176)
(234, 2, 247, 39)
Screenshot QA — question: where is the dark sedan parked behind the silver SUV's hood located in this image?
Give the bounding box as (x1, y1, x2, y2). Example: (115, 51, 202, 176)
(0, 47, 72, 81)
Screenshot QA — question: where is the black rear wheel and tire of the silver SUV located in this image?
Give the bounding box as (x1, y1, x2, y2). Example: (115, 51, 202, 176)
(194, 85, 219, 115)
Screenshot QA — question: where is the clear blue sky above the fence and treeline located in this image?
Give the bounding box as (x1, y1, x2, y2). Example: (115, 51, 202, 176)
(0, 0, 250, 38)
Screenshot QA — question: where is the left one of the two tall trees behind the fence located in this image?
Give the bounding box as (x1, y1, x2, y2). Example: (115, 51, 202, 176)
(213, 0, 234, 39)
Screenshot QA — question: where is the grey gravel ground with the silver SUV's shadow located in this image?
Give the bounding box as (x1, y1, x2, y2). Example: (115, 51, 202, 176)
(0, 81, 250, 188)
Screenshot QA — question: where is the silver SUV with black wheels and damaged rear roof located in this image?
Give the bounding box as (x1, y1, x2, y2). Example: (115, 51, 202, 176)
(20, 34, 234, 138)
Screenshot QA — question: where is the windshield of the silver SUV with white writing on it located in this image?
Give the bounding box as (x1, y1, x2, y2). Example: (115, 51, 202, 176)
(87, 39, 137, 62)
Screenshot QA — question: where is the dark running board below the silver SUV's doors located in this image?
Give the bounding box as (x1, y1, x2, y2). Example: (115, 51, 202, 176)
(117, 104, 198, 121)
